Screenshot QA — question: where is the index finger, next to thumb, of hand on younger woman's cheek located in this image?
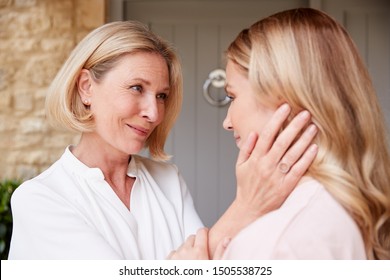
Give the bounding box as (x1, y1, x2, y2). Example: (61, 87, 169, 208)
(252, 103, 291, 158)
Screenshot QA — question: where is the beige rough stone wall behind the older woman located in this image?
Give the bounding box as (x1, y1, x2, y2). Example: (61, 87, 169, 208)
(0, 0, 106, 180)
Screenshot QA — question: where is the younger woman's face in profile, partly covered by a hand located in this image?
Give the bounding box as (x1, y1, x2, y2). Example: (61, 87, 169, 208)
(223, 61, 276, 148)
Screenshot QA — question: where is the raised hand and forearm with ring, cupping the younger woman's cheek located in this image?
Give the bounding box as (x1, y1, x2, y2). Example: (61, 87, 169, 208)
(208, 103, 317, 256)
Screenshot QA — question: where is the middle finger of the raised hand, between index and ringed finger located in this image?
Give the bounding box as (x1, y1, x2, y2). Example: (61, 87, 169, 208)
(269, 111, 310, 162)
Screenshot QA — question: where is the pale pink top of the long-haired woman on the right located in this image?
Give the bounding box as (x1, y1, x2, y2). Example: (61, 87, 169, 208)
(224, 180, 366, 260)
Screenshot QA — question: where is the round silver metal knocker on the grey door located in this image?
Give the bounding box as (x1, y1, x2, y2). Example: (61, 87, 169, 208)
(203, 69, 230, 107)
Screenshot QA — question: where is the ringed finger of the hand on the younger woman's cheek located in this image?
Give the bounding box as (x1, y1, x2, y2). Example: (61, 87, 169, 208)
(280, 124, 318, 166)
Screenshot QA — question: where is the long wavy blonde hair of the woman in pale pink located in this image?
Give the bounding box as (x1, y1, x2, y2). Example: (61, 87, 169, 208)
(227, 8, 390, 259)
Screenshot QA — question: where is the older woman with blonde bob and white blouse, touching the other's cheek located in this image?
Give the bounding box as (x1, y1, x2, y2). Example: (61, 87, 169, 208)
(9, 21, 316, 259)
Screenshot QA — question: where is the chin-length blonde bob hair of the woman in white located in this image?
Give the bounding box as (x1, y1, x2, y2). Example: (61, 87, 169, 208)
(46, 21, 183, 160)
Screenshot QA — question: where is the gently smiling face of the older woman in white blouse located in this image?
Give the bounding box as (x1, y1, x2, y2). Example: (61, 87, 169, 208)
(90, 52, 169, 154)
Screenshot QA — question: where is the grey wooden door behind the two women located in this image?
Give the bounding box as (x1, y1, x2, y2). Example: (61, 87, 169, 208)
(110, 0, 390, 226)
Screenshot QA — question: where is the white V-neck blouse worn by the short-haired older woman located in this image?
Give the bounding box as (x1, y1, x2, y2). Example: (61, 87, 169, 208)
(9, 147, 202, 259)
